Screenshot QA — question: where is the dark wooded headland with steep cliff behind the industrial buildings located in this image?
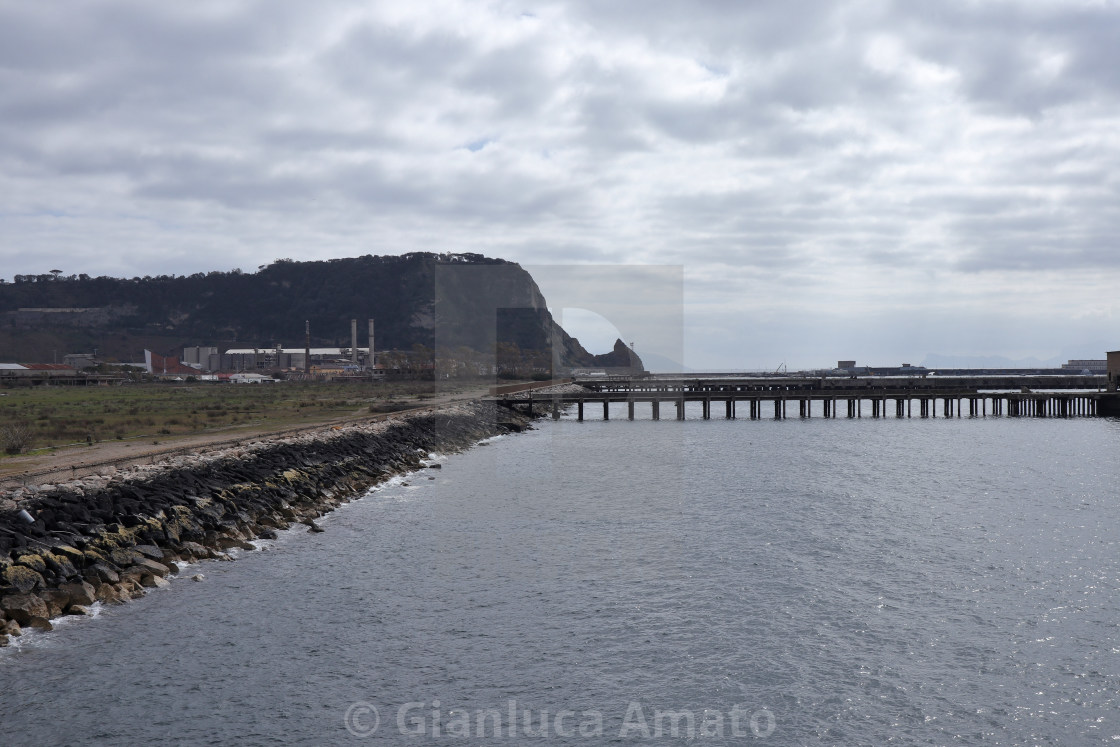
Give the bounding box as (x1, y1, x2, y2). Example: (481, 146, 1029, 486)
(0, 252, 640, 366)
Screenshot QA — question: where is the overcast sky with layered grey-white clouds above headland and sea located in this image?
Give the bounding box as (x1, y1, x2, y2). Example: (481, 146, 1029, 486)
(0, 0, 1120, 370)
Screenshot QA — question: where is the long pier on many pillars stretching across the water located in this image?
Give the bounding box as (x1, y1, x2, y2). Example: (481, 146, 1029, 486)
(491, 375, 1120, 421)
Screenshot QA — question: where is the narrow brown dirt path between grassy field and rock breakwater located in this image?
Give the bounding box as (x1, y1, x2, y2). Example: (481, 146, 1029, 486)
(0, 389, 488, 493)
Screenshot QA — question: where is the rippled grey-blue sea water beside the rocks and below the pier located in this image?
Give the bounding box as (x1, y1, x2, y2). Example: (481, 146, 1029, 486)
(0, 408, 1120, 745)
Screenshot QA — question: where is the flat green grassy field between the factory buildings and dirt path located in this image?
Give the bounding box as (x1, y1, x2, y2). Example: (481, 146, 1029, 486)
(0, 382, 486, 459)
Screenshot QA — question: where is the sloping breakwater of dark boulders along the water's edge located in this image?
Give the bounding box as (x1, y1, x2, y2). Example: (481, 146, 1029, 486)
(0, 403, 528, 645)
